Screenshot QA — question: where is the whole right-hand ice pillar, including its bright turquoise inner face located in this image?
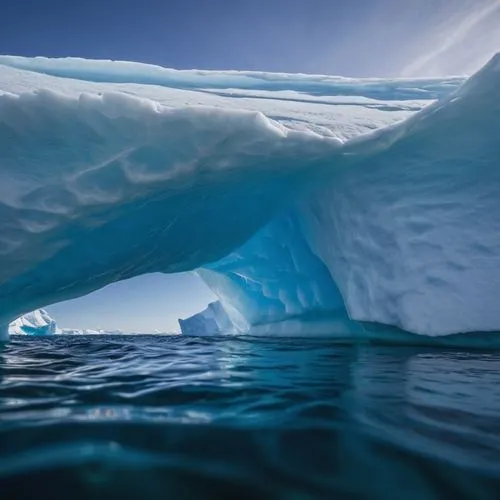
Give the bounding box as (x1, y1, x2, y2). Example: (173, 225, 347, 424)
(193, 57, 500, 336)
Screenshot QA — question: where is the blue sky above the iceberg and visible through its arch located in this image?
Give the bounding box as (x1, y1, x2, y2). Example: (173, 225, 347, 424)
(0, 0, 500, 332)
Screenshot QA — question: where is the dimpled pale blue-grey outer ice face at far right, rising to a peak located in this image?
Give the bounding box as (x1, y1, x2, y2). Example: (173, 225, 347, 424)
(298, 56, 500, 335)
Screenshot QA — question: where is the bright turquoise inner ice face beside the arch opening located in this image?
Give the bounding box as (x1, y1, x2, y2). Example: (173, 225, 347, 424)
(198, 212, 344, 332)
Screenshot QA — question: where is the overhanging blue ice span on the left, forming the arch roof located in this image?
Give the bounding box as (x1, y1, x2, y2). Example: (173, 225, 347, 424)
(0, 91, 339, 340)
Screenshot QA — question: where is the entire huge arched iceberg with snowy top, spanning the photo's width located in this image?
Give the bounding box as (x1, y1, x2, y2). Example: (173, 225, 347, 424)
(0, 56, 500, 337)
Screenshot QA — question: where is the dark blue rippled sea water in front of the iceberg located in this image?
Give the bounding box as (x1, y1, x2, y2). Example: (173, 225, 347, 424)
(0, 336, 500, 500)
